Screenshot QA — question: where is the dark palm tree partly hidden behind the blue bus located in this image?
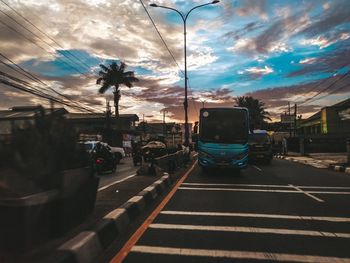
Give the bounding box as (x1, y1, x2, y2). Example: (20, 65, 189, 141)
(236, 96, 271, 129)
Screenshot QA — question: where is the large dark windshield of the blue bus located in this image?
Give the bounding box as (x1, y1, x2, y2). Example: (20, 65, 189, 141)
(199, 109, 248, 144)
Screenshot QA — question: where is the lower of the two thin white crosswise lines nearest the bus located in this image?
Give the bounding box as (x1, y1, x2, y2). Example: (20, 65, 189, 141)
(179, 187, 350, 195)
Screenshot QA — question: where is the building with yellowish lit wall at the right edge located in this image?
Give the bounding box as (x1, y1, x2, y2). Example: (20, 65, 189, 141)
(298, 99, 350, 136)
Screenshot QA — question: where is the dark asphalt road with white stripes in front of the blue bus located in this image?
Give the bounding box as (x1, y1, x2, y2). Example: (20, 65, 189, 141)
(110, 160, 350, 263)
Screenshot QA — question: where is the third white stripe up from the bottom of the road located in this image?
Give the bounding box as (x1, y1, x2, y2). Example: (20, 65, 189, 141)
(160, 210, 350, 223)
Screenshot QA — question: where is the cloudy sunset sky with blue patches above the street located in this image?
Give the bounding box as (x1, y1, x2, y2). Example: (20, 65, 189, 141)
(0, 0, 350, 121)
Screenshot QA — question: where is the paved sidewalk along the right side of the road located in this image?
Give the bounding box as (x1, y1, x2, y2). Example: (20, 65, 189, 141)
(275, 152, 350, 174)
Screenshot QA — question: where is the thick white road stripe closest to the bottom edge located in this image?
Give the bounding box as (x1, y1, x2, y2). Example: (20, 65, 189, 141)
(131, 246, 350, 263)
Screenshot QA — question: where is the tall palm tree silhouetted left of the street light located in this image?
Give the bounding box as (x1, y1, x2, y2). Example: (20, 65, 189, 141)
(96, 61, 139, 117)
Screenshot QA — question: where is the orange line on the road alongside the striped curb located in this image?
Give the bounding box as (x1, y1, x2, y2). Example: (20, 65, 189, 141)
(110, 161, 198, 263)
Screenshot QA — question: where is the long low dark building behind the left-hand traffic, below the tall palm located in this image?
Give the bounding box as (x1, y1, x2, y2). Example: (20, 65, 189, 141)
(0, 106, 139, 146)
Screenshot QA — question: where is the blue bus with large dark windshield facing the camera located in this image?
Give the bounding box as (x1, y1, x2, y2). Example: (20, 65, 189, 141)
(197, 107, 249, 171)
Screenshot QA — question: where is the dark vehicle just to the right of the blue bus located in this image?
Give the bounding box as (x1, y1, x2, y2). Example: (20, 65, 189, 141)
(248, 130, 273, 164)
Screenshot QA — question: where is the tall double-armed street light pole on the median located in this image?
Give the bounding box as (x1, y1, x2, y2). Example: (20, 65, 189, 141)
(150, 0, 220, 146)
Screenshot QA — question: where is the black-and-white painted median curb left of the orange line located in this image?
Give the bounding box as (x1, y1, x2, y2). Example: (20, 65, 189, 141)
(54, 173, 172, 263)
